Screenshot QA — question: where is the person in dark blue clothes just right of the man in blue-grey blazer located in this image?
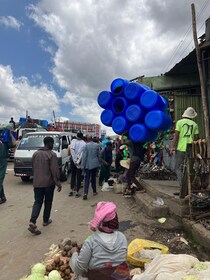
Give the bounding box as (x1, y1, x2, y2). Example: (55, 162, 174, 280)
(99, 142, 112, 186)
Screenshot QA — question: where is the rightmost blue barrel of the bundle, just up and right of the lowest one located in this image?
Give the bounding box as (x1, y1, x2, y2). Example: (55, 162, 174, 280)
(144, 110, 172, 131)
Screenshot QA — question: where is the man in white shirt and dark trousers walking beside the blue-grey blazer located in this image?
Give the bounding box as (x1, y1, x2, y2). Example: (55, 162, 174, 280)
(69, 132, 86, 197)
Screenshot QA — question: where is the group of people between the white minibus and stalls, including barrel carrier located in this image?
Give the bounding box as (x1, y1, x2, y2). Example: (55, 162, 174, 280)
(69, 132, 145, 200)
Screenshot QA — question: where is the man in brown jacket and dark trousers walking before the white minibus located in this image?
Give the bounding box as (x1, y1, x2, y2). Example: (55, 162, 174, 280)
(28, 136, 62, 235)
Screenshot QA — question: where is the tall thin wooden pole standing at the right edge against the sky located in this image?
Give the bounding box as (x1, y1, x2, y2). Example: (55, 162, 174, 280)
(191, 3, 210, 190)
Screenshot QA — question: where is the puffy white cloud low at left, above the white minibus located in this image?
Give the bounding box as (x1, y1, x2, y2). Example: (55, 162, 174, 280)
(0, 65, 59, 123)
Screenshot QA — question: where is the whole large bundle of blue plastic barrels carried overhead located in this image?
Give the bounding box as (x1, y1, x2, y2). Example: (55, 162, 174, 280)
(98, 78, 172, 142)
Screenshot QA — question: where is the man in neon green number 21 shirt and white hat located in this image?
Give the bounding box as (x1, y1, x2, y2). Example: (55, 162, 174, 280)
(170, 107, 199, 192)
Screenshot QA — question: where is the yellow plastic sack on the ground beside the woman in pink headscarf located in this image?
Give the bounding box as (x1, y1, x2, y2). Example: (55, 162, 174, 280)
(127, 238, 169, 267)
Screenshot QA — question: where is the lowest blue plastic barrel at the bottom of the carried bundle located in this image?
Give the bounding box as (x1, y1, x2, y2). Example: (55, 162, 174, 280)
(129, 123, 158, 143)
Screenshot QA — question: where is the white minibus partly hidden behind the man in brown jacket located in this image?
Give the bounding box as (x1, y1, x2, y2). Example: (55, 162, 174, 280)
(14, 131, 70, 181)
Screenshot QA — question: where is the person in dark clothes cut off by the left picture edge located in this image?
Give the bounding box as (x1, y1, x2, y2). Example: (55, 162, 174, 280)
(0, 128, 16, 204)
